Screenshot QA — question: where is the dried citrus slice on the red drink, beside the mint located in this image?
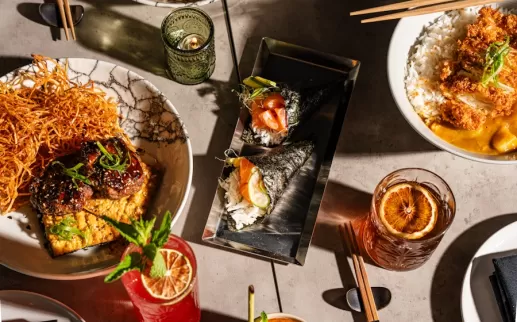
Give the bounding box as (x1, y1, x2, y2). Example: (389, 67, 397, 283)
(142, 249, 193, 300)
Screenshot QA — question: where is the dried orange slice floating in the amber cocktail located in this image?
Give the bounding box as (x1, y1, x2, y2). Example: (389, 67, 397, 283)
(379, 183, 438, 239)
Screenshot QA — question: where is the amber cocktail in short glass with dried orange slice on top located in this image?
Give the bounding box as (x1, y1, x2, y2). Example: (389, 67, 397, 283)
(363, 169, 456, 271)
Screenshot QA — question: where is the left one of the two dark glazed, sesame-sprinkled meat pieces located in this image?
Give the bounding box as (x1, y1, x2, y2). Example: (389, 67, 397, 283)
(29, 155, 93, 215)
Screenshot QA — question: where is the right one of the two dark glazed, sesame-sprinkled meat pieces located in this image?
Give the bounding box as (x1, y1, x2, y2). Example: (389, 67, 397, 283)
(91, 138, 144, 199)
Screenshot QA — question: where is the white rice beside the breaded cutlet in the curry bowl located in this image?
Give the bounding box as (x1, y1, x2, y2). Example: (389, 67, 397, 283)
(405, 7, 479, 120)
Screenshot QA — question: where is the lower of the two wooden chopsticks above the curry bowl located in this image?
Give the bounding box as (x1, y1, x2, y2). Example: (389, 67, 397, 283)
(361, 0, 506, 23)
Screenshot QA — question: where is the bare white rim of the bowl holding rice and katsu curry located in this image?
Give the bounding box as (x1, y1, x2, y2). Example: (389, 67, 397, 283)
(387, 2, 517, 164)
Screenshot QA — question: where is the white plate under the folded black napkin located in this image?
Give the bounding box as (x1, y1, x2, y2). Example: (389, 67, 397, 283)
(461, 222, 517, 322)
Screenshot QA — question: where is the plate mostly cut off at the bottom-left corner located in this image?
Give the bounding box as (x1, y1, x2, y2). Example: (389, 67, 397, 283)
(0, 291, 84, 322)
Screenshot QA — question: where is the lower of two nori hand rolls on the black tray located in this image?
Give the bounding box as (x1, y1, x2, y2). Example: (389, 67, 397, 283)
(220, 141, 314, 230)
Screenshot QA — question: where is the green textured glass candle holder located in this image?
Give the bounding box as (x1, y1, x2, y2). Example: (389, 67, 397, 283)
(161, 8, 215, 85)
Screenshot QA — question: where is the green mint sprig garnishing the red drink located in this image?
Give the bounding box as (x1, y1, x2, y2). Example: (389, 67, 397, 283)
(102, 211, 172, 283)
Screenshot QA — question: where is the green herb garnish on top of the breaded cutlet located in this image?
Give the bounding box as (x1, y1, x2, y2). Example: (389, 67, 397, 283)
(481, 36, 510, 87)
